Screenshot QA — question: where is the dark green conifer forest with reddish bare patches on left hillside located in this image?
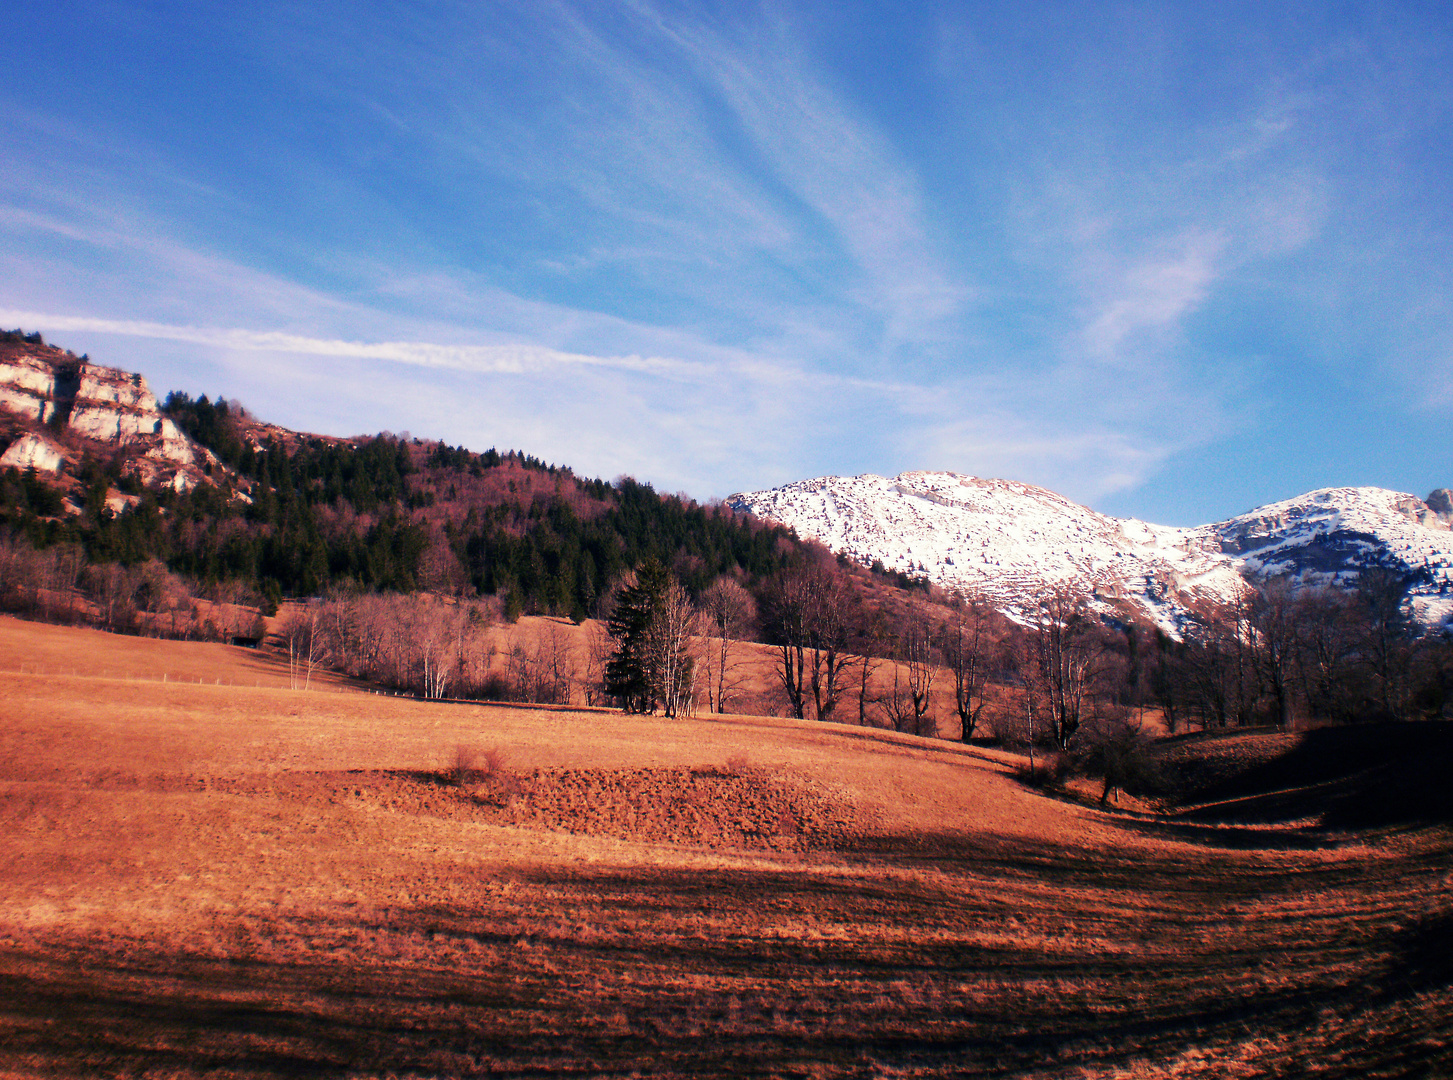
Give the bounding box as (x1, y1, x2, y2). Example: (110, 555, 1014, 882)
(0, 392, 801, 619)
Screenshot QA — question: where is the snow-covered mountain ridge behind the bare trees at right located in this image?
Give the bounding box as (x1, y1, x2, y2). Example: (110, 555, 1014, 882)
(727, 472, 1453, 631)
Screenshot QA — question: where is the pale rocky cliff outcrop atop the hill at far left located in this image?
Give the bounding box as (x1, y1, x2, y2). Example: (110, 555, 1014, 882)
(0, 334, 218, 491)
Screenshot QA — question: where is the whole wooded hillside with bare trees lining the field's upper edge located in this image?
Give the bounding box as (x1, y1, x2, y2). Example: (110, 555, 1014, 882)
(0, 350, 1453, 738)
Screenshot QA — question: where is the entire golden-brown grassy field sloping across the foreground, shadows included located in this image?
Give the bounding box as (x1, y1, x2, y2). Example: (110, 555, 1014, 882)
(0, 619, 1453, 1077)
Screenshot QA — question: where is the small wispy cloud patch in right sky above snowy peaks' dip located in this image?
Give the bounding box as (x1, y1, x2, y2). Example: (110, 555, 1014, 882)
(1011, 89, 1328, 430)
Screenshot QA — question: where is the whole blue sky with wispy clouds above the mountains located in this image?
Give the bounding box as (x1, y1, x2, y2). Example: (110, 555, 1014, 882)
(0, 0, 1453, 525)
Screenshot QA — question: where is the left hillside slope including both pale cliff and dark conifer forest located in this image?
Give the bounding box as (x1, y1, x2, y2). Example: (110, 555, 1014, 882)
(0, 331, 804, 618)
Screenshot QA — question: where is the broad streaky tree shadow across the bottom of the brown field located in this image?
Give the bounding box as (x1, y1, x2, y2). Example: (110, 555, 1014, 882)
(11, 802, 1453, 1077)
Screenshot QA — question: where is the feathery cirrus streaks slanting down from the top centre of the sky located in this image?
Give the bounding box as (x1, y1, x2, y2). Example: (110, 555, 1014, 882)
(358, 3, 974, 366)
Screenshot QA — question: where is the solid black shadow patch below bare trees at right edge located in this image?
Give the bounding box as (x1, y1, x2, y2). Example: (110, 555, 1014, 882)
(1177, 721, 1453, 829)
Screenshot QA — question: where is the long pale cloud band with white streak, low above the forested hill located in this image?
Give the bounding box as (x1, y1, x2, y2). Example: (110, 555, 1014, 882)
(0, 75, 1185, 505)
